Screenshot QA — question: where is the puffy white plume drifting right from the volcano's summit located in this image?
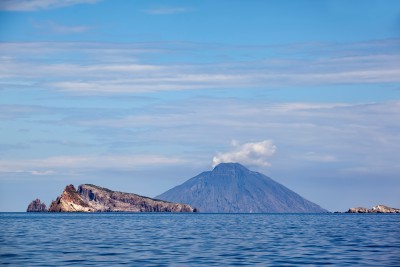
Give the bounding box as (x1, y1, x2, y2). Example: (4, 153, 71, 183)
(213, 140, 276, 167)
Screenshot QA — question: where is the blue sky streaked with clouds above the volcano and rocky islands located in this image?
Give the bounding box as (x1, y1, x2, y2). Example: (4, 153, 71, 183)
(0, 0, 400, 214)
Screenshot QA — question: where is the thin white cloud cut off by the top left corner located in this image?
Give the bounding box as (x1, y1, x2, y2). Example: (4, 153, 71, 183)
(0, 0, 101, 11)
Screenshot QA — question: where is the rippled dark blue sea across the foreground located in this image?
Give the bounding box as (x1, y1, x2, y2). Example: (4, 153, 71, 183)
(0, 213, 400, 266)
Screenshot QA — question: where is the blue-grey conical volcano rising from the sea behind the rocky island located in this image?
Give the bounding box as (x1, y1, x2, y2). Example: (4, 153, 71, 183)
(156, 163, 327, 212)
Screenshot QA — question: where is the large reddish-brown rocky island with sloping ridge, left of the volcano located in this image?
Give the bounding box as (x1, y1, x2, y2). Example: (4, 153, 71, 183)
(49, 184, 195, 212)
